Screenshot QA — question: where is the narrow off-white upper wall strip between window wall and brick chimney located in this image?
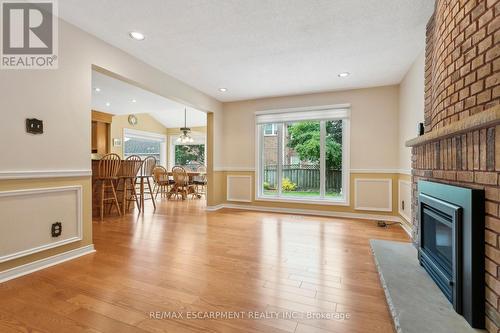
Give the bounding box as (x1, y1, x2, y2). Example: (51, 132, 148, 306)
(398, 51, 425, 174)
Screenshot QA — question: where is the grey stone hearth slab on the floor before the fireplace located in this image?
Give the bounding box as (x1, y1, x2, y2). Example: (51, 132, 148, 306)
(370, 240, 486, 333)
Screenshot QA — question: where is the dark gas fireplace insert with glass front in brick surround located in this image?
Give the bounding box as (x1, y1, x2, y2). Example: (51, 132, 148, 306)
(418, 181, 484, 328)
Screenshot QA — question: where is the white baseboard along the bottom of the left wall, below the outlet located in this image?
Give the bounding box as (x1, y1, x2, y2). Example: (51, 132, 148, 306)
(0, 244, 95, 283)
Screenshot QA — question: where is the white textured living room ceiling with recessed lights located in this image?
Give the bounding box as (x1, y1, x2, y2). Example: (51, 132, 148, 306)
(59, 0, 434, 101)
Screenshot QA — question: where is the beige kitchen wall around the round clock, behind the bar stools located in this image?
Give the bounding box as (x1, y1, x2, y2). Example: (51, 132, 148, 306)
(111, 113, 168, 158)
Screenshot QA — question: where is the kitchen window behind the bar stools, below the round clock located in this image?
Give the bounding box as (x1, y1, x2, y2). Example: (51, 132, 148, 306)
(123, 128, 167, 166)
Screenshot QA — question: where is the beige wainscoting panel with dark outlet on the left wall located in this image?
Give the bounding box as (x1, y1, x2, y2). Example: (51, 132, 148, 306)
(0, 186, 83, 262)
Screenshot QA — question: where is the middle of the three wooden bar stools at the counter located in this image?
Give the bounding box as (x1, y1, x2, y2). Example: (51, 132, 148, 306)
(118, 155, 142, 215)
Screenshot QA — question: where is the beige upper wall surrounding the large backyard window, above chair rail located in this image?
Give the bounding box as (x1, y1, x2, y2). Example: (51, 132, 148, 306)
(221, 86, 398, 170)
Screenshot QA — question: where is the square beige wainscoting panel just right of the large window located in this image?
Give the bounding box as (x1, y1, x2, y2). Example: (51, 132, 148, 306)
(354, 178, 392, 212)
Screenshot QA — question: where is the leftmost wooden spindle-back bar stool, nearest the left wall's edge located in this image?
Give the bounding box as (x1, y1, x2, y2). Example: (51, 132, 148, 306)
(94, 154, 122, 221)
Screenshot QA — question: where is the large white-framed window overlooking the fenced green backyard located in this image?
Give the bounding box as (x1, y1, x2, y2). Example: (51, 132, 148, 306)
(256, 108, 349, 204)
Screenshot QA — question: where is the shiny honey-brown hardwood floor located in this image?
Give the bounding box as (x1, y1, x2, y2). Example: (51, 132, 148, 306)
(0, 200, 408, 333)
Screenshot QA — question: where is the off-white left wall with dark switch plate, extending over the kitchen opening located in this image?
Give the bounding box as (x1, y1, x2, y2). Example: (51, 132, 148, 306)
(0, 21, 222, 173)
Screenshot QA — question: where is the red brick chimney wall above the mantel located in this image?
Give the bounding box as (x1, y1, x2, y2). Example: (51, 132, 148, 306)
(425, 0, 500, 131)
